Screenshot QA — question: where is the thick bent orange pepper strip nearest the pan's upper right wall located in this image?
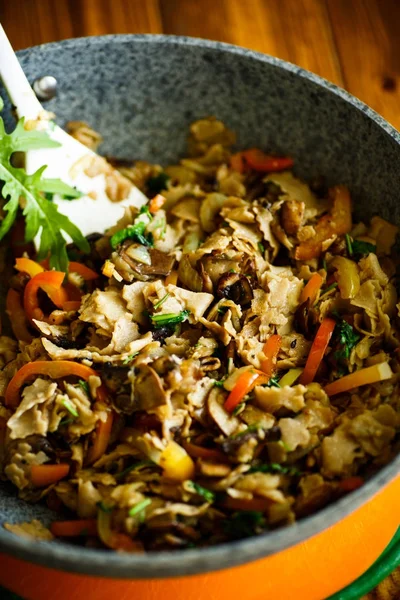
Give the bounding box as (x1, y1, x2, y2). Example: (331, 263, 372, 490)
(294, 185, 352, 260)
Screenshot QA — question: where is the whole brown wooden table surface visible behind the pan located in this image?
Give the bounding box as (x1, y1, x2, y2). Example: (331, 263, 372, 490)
(0, 0, 400, 600)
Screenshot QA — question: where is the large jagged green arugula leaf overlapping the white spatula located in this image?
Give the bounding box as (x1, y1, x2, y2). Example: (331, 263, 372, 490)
(0, 113, 90, 272)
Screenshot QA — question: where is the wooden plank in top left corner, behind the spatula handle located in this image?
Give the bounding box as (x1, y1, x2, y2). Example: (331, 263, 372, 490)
(0, 0, 162, 50)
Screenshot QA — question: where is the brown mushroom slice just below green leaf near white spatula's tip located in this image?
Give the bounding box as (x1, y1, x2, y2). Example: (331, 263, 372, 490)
(119, 240, 175, 281)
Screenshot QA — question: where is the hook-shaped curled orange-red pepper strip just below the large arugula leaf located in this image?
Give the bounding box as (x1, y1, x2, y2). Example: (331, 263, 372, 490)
(24, 271, 68, 325)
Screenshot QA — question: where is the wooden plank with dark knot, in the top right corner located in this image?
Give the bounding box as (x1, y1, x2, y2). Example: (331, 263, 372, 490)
(327, 0, 400, 129)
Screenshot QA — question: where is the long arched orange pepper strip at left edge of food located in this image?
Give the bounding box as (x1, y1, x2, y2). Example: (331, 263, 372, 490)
(5, 360, 107, 408)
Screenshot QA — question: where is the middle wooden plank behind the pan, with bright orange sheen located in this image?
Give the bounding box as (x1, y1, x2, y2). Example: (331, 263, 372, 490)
(160, 0, 342, 84)
